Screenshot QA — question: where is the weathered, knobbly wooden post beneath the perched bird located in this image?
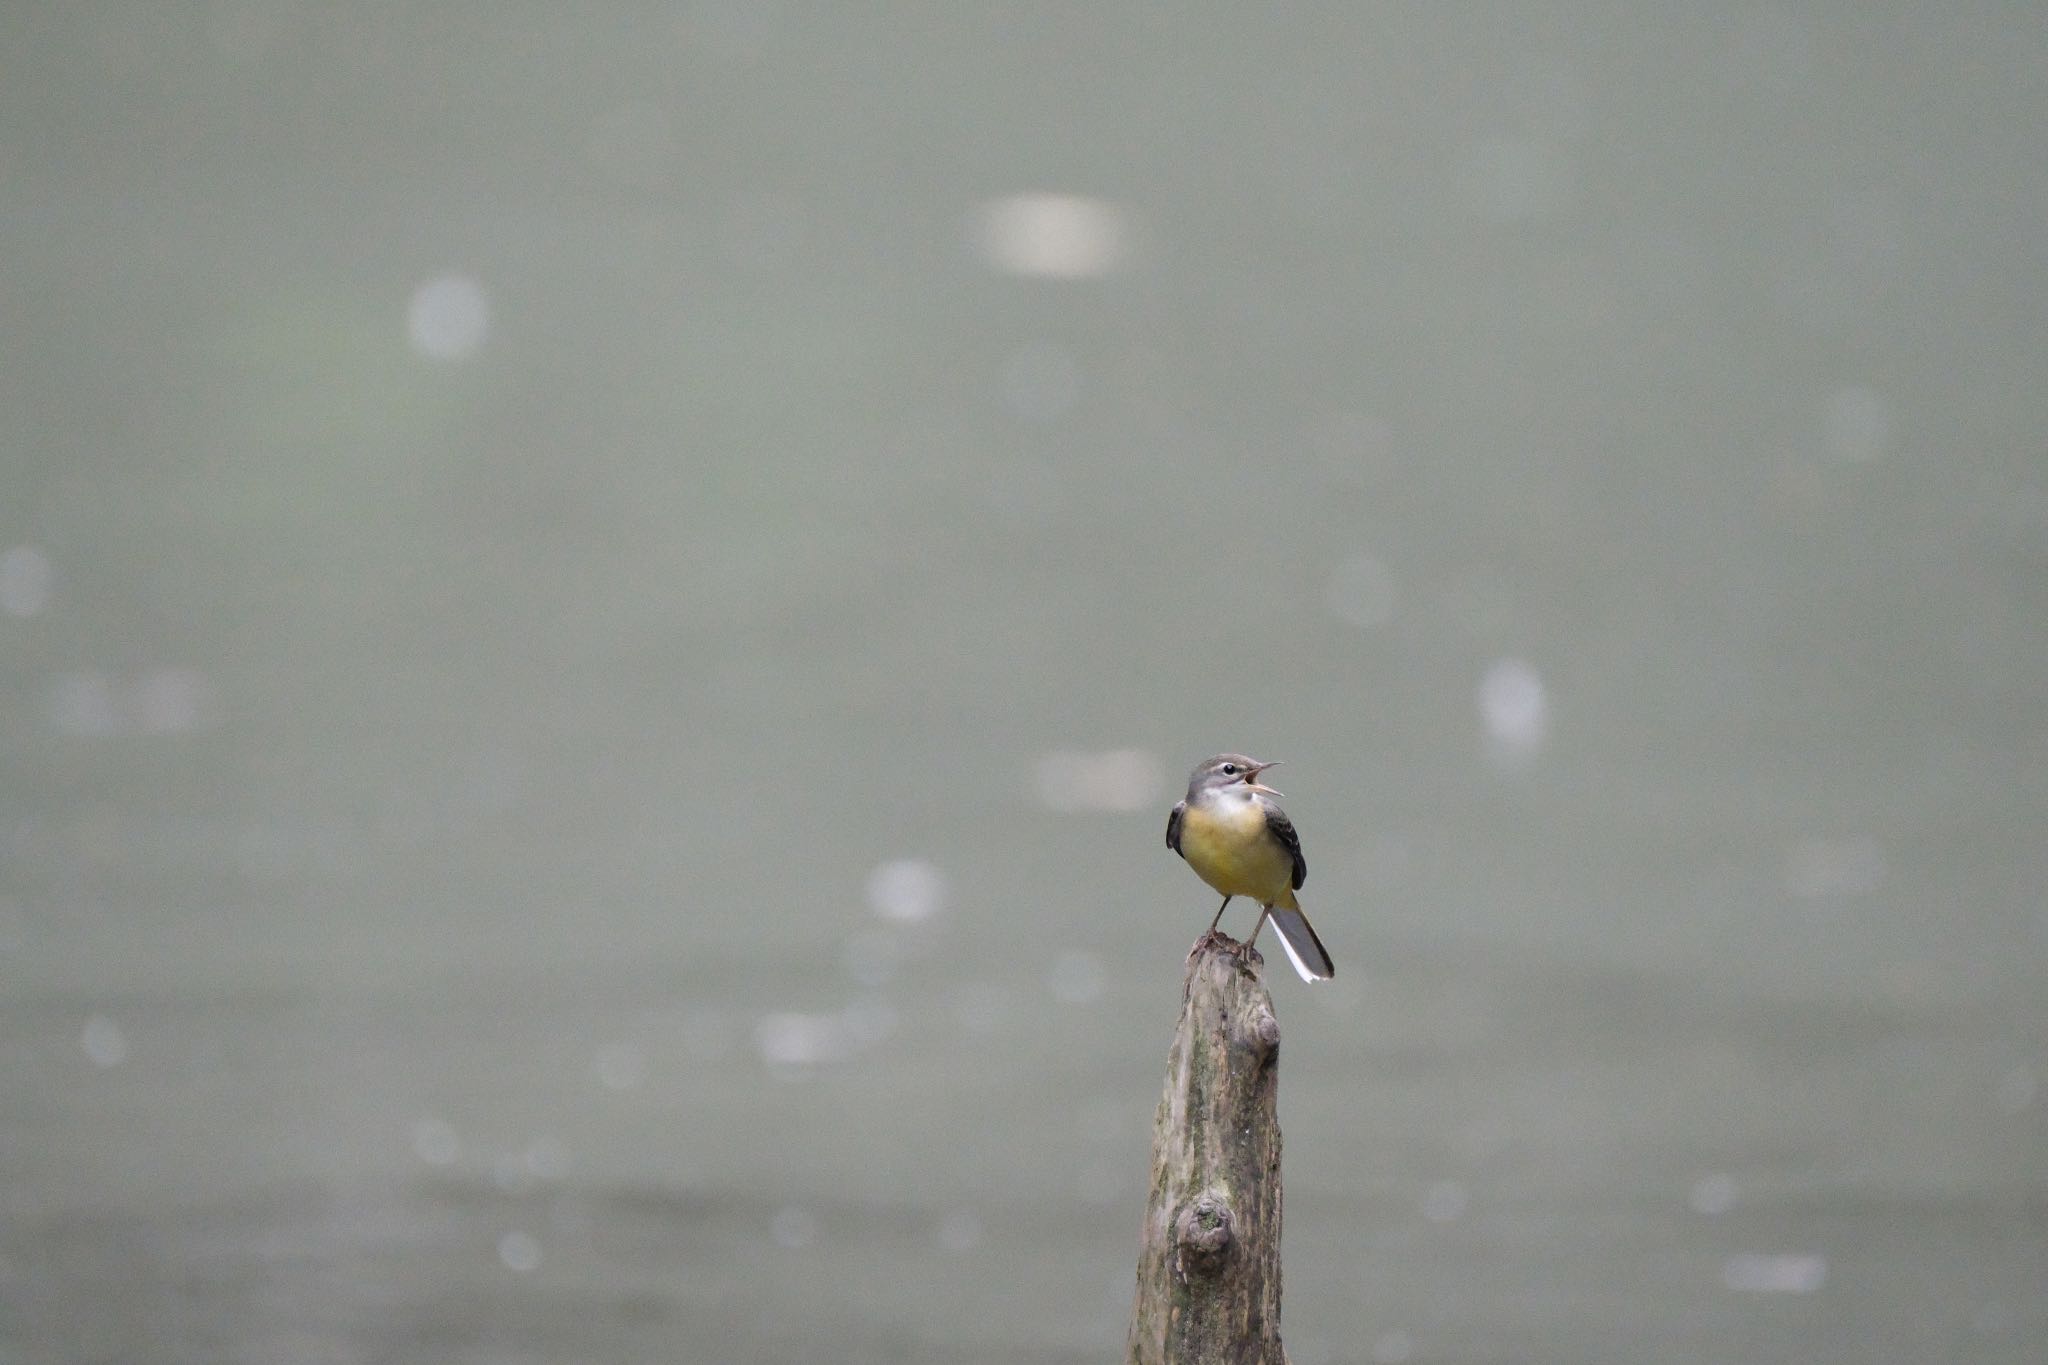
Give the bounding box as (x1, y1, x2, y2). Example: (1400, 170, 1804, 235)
(1126, 933, 1286, 1365)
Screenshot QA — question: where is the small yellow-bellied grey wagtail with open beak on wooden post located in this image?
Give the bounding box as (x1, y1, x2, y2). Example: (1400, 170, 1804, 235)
(1165, 753, 1337, 980)
